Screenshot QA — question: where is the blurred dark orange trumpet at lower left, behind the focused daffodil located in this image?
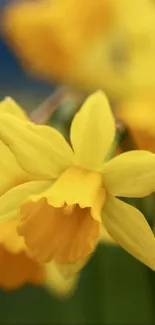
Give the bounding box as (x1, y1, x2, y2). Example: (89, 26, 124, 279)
(0, 220, 45, 290)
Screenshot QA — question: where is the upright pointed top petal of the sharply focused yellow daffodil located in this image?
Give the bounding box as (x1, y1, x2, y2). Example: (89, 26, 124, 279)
(70, 91, 115, 169)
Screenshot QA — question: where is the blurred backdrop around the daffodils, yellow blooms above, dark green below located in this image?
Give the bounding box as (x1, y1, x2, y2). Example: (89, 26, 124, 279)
(0, 0, 155, 325)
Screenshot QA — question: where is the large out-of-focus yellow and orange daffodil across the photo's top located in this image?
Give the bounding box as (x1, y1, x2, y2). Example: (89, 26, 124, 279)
(3, 0, 155, 96)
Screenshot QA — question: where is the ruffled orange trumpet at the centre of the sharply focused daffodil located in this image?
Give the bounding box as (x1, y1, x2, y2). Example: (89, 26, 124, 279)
(18, 167, 106, 264)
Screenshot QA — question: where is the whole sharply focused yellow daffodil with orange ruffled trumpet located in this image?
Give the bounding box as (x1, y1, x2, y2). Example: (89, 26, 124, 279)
(0, 91, 155, 275)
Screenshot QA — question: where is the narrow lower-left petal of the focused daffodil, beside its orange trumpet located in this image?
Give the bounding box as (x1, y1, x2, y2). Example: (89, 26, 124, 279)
(0, 181, 51, 221)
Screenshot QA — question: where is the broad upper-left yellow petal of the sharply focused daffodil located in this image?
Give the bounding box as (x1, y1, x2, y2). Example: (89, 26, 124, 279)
(0, 114, 73, 179)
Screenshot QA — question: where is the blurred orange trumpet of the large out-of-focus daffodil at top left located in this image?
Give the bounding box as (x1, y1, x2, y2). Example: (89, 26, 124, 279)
(4, 0, 107, 90)
